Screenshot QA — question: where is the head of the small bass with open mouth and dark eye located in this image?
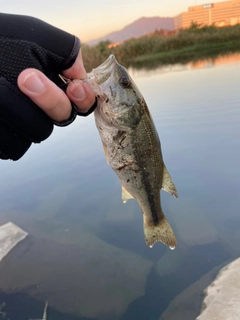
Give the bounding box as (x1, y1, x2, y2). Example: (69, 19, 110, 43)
(88, 55, 145, 127)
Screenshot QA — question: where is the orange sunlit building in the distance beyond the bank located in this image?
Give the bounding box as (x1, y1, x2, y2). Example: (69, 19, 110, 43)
(174, 0, 240, 30)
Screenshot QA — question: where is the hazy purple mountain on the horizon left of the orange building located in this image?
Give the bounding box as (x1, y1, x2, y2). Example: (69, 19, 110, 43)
(88, 17, 174, 45)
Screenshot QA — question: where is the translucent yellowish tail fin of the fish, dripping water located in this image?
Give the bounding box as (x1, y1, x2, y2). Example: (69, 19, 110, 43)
(144, 214, 177, 250)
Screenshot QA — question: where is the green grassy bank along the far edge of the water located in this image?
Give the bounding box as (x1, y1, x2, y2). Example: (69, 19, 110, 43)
(83, 24, 240, 71)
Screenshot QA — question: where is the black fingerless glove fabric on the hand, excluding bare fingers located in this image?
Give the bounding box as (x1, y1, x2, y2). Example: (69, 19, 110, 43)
(0, 13, 80, 160)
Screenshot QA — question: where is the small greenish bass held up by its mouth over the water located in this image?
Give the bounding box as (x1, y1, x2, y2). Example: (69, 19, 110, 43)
(87, 55, 178, 249)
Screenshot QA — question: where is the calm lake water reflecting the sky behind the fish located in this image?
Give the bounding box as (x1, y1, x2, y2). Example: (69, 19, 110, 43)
(0, 55, 240, 320)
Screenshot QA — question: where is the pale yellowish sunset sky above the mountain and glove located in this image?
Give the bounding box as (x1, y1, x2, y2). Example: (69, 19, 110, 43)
(0, 0, 229, 42)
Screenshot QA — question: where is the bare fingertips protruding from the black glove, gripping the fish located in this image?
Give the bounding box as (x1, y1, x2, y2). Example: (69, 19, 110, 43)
(18, 50, 95, 122)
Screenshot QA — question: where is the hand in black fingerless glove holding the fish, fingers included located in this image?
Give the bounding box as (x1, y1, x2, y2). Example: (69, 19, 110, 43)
(0, 14, 95, 160)
